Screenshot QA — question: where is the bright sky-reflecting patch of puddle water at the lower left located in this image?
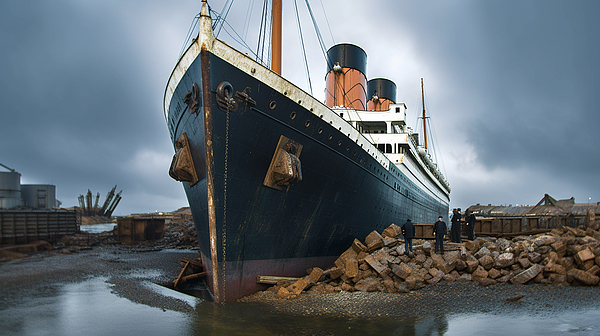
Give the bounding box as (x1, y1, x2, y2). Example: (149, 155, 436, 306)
(0, 278, 190, 336)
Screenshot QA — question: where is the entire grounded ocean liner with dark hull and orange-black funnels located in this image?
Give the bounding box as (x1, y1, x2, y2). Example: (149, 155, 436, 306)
(164, 0, 450, 302)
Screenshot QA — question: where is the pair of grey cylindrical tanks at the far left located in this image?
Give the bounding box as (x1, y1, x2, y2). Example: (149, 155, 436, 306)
(0, 163, 61, 210)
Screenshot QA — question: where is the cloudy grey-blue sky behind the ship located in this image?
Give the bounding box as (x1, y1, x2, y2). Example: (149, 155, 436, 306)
(0, 0, 600, 215)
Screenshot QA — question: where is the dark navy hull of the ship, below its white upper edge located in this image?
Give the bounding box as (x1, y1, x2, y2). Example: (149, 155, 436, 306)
(167, 50, 448, 302)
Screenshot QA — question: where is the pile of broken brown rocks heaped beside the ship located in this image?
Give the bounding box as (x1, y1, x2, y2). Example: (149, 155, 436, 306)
(268, 224, 600, 299)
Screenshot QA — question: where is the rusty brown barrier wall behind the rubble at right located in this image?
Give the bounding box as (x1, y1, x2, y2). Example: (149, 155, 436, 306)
(463, 194, 600, 236)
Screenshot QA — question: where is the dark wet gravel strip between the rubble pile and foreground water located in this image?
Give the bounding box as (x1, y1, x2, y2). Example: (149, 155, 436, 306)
(240, 281, 600, 317)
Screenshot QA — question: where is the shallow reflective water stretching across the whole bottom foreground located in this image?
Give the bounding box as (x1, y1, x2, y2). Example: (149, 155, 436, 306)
(0, 276, 600, 336)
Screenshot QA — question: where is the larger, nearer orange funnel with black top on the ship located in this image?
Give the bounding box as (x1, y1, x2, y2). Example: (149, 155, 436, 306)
(325, 43, 367, 111)
